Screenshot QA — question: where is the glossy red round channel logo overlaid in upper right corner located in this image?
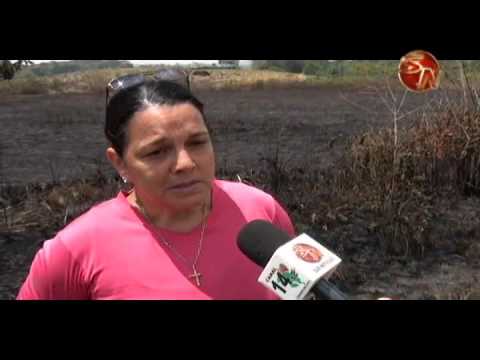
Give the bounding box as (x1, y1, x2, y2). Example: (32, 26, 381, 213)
(398, 50, 440, 92)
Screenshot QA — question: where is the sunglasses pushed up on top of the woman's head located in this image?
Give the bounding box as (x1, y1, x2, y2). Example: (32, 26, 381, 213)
(105, 69, 193, 106)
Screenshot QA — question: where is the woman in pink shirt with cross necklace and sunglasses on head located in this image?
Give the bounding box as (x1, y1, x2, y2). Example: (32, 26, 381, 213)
(18, 69, 294, 300)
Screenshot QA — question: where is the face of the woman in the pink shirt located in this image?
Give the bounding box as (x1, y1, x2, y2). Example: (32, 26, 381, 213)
(110, 103, 215, 209)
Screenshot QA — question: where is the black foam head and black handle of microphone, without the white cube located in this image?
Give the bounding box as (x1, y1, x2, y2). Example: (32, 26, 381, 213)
(237, 220, 349, 300)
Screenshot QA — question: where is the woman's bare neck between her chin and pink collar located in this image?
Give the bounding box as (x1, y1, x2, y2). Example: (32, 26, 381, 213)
(128, 190, 212, 232)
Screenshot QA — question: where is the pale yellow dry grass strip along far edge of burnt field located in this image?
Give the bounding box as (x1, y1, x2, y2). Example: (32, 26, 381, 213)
(0, 62, 480, 95)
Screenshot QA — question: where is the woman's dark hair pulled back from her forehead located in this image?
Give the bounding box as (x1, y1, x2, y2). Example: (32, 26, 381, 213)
(105, 80, 210, 156)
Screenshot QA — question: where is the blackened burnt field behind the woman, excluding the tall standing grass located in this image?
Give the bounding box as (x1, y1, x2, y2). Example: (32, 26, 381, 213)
(0, 86, 480, 299)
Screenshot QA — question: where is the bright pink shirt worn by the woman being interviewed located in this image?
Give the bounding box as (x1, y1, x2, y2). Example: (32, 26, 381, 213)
(17, 180, 294, 300)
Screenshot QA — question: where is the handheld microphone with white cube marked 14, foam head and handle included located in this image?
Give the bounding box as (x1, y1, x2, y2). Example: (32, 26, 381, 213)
(237, 220, 348, 300)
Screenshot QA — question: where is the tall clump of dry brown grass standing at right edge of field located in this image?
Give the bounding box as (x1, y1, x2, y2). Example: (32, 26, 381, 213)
(335, 90, 480, 256)
